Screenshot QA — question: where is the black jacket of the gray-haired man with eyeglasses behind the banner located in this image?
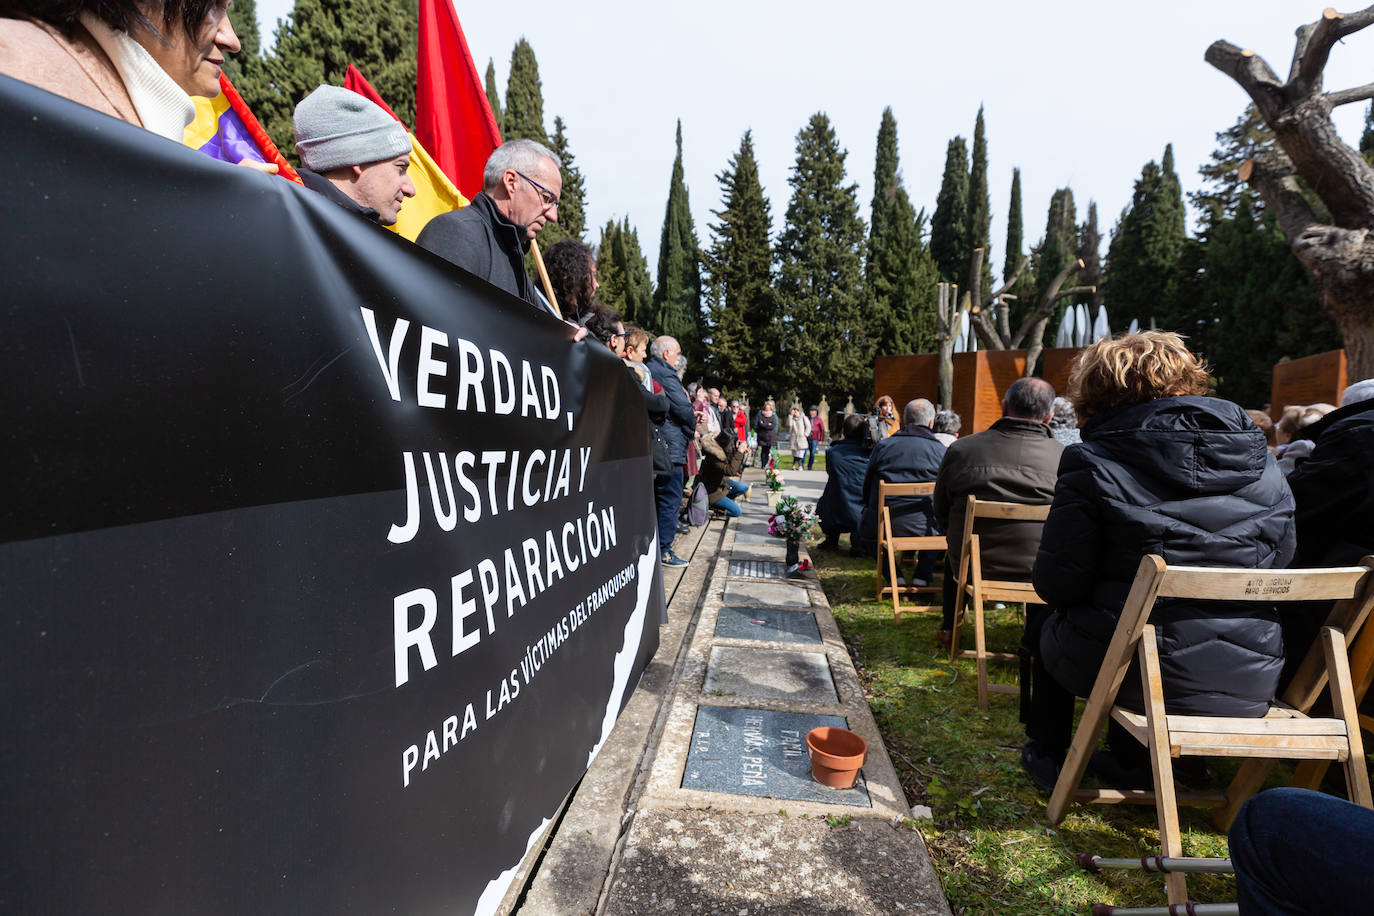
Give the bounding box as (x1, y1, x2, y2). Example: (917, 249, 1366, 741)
(415, 192, 543, 308)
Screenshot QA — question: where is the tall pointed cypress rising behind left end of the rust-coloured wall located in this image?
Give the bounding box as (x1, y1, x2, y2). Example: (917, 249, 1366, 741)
(864, 107, 938, 356)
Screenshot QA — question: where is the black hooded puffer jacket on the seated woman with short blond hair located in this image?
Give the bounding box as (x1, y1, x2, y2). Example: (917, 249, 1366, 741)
(1035, 397, 1294, 715)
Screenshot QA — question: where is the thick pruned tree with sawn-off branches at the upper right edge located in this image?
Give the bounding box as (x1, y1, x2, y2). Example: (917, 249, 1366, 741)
(1205, 7, 1374, 379)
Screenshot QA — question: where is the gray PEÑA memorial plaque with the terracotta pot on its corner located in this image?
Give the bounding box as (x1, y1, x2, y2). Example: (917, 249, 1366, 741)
(683, 706, 872, 808)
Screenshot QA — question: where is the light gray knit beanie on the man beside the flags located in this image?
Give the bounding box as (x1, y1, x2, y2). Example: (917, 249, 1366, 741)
(294, 87, 411, 172)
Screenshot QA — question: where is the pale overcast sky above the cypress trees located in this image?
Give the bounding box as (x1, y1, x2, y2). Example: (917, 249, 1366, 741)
(258, 0, 1374, 276)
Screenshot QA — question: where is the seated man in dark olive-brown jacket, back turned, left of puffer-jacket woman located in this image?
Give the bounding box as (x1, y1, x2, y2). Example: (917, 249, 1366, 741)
(934, 379, 1063, 645)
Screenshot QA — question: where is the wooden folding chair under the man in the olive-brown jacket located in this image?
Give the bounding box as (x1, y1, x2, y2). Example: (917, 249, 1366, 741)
(949, 496, 1050, 709)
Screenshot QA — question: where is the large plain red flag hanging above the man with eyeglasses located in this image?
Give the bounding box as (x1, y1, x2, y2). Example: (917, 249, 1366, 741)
(415, 0, 502, 198)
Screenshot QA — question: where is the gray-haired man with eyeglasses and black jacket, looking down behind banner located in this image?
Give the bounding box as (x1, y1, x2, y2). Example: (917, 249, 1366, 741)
(415, 140, 563, 308)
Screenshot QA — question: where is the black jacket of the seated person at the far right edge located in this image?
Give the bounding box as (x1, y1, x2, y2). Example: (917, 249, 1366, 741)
(1289, 401, 1374, 566)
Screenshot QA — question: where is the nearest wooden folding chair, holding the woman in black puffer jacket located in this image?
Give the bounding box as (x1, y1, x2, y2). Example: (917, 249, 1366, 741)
(1048, 555, 1374, 905)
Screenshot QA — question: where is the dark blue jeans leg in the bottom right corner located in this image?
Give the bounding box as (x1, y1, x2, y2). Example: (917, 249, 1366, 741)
(1230, 788, 1374, 916)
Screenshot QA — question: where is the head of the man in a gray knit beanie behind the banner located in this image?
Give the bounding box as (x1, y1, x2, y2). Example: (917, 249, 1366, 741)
(294, 87, 415, 225)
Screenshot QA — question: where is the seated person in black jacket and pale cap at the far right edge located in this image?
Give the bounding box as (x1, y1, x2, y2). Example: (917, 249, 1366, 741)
(1279, 379, 1374, 684)
